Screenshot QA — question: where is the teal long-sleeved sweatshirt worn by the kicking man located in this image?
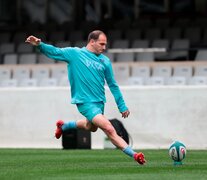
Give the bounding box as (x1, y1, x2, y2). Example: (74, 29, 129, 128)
(37, 42, 128, 112)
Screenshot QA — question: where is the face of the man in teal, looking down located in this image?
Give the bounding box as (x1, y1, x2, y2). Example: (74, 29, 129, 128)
(91, 34, 107, 54)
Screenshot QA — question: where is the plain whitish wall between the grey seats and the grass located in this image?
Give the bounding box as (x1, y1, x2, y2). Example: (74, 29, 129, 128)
(0, 86, 207, 149)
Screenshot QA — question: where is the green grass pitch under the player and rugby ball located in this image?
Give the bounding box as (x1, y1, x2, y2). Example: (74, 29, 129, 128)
(0, 149, 207, 180)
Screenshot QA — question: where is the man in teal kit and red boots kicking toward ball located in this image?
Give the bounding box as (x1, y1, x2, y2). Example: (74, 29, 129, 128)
(26, 30, 145, 164)
